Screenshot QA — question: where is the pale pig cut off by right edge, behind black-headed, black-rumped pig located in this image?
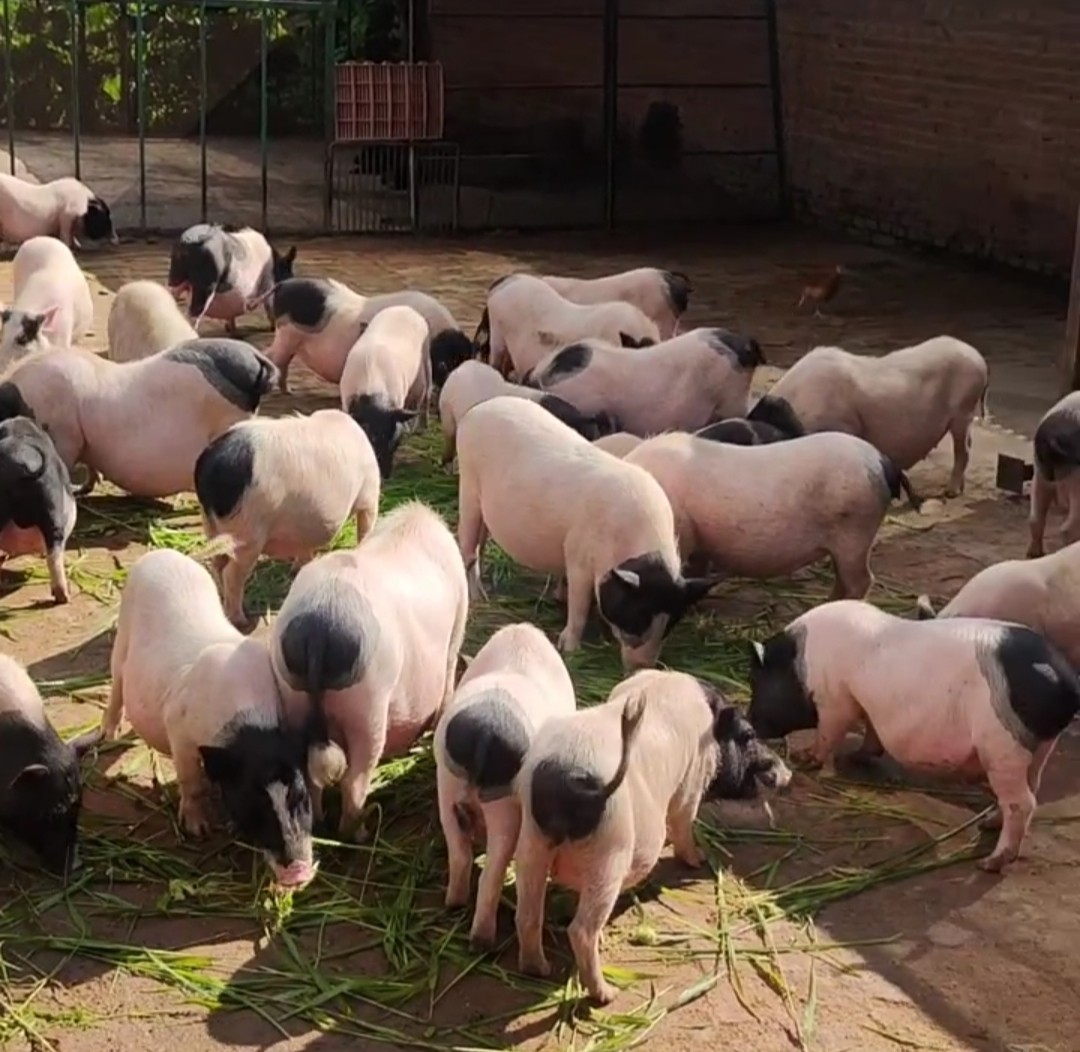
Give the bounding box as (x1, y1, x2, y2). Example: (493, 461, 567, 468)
(916, 542, 1080, 669)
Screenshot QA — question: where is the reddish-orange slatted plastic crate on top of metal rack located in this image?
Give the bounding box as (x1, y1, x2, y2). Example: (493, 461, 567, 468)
(335, 62, 443, 139)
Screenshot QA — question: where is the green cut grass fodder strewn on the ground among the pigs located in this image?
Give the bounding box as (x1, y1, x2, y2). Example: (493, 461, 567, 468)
(0, 421, 989, 1052)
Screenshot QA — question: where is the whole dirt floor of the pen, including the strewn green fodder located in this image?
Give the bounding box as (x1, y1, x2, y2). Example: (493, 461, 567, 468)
(0, 224, 1080, 1052)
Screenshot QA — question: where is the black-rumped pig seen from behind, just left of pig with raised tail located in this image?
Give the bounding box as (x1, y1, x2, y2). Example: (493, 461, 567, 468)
(434, 624, 577, 949)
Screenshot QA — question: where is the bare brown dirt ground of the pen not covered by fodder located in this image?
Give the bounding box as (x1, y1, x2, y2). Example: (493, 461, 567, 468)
(0, 228, 1080, 1052)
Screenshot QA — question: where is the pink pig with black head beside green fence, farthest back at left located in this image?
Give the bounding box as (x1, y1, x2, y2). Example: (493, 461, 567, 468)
(0, 174, 120, 248)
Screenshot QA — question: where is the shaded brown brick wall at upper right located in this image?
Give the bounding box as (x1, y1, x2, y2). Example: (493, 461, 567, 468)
(777, 0, 1080, 272)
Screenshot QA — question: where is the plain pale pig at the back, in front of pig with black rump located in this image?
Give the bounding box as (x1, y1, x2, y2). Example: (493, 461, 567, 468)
(481, 274, 660, 378)
